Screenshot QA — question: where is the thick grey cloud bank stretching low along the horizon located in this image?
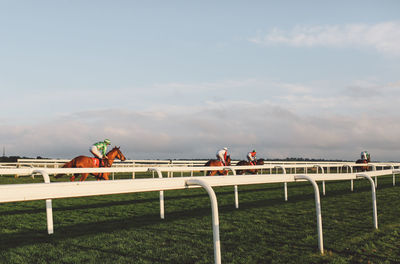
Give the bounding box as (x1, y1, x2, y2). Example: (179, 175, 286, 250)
(0, 98, 400, 160)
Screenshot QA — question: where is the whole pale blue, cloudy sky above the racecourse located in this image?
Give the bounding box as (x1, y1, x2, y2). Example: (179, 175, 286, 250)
(0, 0, 400, 161)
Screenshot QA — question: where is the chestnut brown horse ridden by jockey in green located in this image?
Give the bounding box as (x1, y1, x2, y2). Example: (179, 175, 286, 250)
(56, 147, 126, 181)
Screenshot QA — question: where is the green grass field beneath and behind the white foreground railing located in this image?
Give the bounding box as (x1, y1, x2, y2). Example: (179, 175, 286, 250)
(0, 173, 400, 263)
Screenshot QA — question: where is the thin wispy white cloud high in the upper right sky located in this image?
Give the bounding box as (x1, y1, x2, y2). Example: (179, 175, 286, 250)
(249, 21, 400, 56)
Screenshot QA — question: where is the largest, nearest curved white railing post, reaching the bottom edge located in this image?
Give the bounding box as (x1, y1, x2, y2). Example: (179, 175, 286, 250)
(186, 179, 221, 264)
